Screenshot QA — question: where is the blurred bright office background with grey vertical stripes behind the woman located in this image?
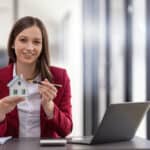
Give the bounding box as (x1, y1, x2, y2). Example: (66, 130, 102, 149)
(0, 0, 150, 139)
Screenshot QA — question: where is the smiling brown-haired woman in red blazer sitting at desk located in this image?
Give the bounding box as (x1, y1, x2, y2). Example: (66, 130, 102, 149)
(0, 16, 72, 138)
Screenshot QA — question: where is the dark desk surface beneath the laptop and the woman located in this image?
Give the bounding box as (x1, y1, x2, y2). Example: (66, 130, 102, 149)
(0, 137, 150, 150)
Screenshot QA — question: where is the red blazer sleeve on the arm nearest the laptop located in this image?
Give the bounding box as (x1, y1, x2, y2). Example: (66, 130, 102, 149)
(42, 70, 73, 137)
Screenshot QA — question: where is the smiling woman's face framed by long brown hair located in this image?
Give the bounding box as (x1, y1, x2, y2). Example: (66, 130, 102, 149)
(12, 26, 42, 65)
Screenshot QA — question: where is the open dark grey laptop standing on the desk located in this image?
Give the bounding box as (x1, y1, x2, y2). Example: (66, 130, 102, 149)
(68, 102, 150, 145)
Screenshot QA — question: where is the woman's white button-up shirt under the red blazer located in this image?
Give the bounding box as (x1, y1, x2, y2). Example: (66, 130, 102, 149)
(13, 65, 41, 137)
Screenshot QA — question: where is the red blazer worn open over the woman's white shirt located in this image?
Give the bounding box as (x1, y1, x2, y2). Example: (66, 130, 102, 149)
(0, 64, 72, 138)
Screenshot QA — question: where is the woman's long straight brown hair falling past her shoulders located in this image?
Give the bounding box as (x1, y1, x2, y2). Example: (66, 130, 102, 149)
(7, 16, 52, 81)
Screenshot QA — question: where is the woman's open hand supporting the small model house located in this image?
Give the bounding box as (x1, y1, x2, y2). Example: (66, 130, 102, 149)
(0, 96, 24, 122)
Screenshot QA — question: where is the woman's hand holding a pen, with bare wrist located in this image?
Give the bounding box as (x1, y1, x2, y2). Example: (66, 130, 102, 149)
(39, 79, 57, 119)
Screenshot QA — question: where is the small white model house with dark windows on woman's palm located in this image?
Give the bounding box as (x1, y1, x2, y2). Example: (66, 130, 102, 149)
(7, 75, 28, 96)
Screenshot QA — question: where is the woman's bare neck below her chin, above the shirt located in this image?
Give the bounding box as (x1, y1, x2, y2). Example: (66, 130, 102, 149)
(16, 62, 36, 80)
